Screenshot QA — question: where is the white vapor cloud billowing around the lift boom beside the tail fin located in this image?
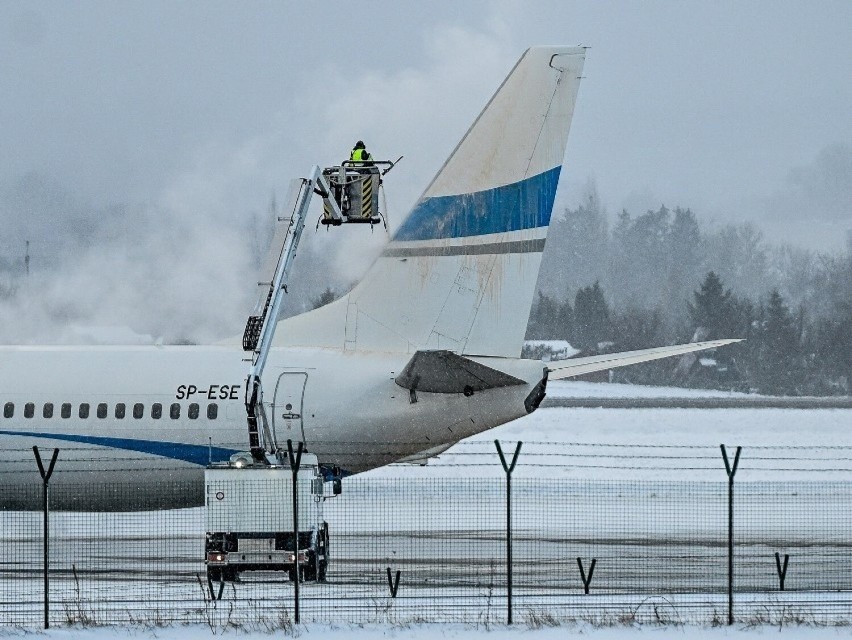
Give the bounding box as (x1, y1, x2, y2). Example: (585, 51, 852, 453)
(0, 17, 518, 343)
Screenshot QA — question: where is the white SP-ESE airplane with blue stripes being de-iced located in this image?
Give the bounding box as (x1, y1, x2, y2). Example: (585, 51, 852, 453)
(0, 46, 732, 511)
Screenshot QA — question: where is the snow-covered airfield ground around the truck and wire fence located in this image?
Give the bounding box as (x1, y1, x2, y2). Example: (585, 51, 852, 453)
(0, 382, 852, 639)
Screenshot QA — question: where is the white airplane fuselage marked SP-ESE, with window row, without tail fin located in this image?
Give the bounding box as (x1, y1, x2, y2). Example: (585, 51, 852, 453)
(0, 346, 543, 510)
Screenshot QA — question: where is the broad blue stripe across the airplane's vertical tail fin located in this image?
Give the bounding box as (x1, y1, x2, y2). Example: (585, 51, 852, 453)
(394, 167, 562, 240)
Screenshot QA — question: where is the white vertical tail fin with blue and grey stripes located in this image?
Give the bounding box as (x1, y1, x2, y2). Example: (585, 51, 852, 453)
(276, 47, 585, 357)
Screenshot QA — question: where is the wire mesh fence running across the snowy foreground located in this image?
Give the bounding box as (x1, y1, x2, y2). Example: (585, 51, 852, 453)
(0, 443, 852, 628)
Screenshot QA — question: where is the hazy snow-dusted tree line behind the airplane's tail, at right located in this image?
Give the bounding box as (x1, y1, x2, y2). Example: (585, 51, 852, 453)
(527, 192, 852, 395)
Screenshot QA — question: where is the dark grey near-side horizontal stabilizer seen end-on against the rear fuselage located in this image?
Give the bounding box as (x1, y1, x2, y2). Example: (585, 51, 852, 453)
(395, 350, 526, 393)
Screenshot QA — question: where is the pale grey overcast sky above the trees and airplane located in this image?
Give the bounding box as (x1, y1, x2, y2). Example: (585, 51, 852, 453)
(0, 0, 852, 342)
